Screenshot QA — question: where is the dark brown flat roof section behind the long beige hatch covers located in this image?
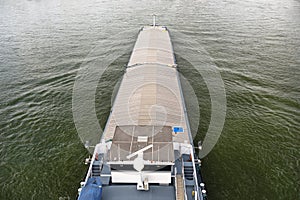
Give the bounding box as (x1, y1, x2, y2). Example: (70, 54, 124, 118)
(109, 125, 175, 162)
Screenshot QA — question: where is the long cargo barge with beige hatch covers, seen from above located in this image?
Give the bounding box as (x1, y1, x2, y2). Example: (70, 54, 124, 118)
(78, 20, 207, 200)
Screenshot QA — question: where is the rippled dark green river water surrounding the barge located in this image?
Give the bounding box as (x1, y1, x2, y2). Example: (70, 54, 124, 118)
(0, 0, 300, 200)
